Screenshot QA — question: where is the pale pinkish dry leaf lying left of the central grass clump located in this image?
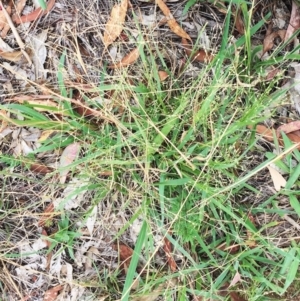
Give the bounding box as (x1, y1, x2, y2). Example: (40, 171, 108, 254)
(59, 143, 80, 184)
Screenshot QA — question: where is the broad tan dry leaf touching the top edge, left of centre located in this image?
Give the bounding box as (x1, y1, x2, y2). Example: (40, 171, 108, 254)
(103, 0, 128, 47)
